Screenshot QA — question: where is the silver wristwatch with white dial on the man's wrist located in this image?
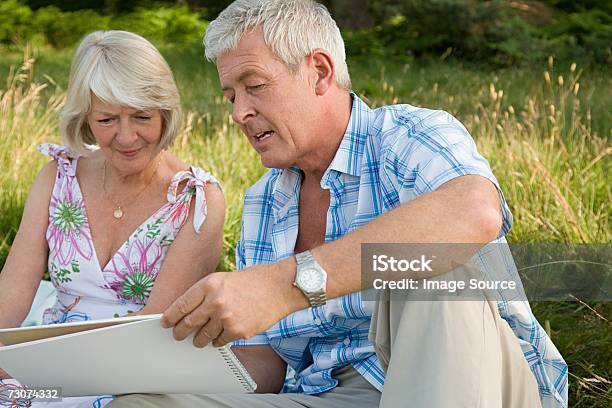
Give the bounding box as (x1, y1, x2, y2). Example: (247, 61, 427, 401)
(293, 251, 327, 307)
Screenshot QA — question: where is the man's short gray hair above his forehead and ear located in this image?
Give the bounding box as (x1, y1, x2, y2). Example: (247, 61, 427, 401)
(204, 0, 351, 90)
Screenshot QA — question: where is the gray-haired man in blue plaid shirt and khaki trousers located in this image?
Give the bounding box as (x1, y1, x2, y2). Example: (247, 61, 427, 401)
(111, 0, 567, 407)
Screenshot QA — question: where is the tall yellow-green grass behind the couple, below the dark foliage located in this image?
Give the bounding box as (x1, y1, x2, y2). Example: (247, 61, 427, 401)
(0, 46, 612, 407)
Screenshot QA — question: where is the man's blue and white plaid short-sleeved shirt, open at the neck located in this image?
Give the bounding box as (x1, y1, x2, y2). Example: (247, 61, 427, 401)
(235, 95, 567, 407)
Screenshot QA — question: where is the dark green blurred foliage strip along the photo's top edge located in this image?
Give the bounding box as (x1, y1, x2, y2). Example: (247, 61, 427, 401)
(0, 0, 612, 65)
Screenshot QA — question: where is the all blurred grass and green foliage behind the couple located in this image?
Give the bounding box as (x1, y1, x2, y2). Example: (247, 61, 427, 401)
(0, 0, 612, 408)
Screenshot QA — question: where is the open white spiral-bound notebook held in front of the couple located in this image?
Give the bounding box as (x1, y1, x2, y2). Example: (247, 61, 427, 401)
(0, 315, 257, 397)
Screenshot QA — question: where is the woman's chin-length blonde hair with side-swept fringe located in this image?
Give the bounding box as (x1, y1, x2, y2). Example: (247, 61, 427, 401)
(60, 31, 182, 153)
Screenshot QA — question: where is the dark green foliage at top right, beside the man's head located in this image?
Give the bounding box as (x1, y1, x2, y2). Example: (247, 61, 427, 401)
(356, 0, 612, 65)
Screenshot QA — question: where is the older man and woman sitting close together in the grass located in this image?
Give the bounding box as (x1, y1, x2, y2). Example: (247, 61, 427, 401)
(0, 0, 567, 408)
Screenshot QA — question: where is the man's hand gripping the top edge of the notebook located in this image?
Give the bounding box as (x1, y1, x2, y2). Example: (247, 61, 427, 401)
(162, 264, 298, 347)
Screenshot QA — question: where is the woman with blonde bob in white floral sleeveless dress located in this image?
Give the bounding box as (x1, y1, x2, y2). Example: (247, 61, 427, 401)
(0, 31, 224, 406)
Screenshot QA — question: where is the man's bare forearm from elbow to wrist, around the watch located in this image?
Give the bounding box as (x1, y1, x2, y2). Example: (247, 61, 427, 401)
(272, 176, 502, 312)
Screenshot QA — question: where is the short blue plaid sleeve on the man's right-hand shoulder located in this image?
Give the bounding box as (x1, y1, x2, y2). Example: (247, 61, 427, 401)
(385, 109, 512, 238)
